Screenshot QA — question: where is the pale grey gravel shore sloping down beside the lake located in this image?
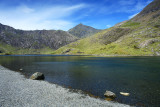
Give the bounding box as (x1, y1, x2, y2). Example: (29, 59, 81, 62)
(0, 66, 129, 107)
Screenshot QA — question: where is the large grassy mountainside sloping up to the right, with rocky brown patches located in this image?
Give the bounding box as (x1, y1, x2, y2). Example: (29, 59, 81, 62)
(54, 0, 160, 56)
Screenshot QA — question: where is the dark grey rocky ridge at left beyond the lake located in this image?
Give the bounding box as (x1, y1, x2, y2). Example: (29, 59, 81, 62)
(0, 24, 77, 53)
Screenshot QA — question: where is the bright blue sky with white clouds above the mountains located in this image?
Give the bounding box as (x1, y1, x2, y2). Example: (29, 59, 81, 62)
(0, 0, 153, 31)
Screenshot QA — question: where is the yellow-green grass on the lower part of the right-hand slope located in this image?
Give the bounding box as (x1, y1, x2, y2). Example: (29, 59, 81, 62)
(54, 24, 160, 56)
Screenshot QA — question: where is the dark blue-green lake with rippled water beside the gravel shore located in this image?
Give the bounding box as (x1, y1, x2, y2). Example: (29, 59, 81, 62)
(0, 55, 160, 107)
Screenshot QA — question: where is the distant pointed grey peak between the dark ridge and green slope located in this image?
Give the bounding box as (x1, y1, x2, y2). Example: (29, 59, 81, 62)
(68, 24, 101, 38)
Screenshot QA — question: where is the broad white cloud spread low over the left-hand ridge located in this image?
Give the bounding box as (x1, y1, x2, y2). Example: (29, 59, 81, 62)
(0, 4, 86, 30)
